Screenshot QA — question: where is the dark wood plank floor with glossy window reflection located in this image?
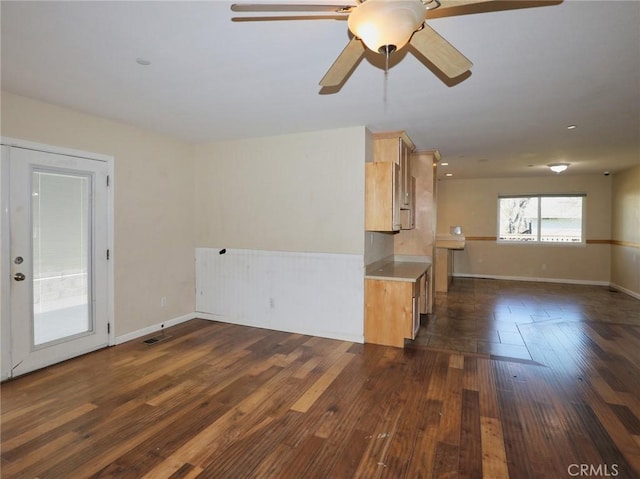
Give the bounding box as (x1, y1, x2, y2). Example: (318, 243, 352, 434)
(1, 279, 640, 479)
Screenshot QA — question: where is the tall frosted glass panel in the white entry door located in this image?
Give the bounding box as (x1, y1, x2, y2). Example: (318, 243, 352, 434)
(31, 170, 93, 348)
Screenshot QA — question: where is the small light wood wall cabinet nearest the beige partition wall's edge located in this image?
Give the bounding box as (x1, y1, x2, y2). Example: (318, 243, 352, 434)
(364, 162, 402, 231)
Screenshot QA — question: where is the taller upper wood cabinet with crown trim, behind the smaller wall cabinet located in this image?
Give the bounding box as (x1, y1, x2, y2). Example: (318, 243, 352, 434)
(373, 131, 415, 209)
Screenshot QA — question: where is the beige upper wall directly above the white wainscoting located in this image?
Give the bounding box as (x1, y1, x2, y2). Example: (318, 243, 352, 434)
(195, 127, 369, 254)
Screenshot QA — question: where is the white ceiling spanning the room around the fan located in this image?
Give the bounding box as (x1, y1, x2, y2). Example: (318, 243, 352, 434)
(0, 0, 640, 178)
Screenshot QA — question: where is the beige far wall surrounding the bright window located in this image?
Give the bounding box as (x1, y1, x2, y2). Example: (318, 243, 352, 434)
(437, 175, 612, 284)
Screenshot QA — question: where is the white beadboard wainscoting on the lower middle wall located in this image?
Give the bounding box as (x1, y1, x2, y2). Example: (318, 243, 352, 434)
(196, 248, 364, 343)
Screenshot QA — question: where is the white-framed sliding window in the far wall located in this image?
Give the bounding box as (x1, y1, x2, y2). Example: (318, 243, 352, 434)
(498, 195, 584, 244)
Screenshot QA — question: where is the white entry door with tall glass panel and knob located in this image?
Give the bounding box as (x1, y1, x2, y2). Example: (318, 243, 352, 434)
(4, 147, 109, 376)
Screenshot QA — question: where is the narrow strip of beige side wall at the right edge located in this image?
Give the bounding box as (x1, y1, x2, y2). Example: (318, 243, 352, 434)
(611, 165, 640, 297)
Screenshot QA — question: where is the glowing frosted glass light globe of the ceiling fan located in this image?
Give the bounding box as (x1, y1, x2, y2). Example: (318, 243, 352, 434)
(348, 0, 426, 52)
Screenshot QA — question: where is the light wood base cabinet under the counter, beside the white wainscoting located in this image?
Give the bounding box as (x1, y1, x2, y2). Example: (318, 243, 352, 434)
(364, 275, 425, 348)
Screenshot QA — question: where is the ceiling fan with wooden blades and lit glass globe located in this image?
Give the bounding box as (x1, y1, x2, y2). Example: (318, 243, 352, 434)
(231, 0, 560, 87)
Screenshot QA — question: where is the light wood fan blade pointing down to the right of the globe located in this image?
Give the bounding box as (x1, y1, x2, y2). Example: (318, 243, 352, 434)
(410, 24, 473, 78)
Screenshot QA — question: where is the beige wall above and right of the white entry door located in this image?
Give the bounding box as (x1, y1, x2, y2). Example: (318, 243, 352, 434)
(0, 92, 195, 336)
